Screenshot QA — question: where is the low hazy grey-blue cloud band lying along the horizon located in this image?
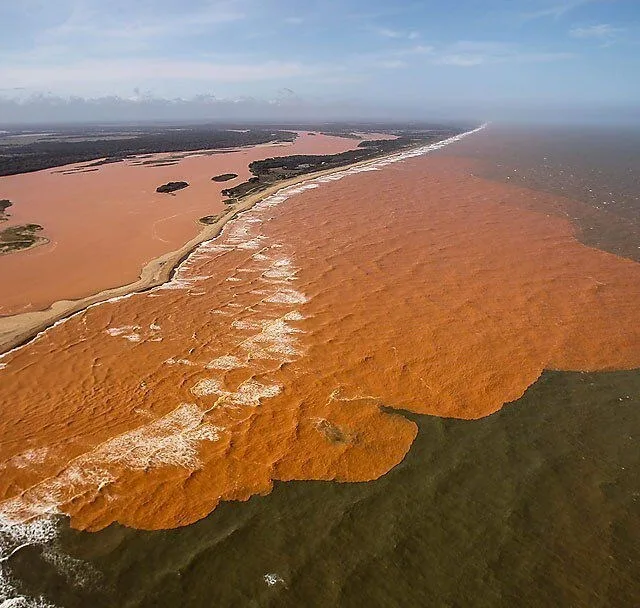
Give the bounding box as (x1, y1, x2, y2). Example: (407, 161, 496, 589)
(0, 96, 640, 127)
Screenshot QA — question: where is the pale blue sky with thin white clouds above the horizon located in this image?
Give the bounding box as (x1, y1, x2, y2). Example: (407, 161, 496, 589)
(0, 0, 640, 123)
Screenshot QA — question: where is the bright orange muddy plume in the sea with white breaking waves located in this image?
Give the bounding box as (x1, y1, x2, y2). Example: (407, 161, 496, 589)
(0, 135, 640, 530)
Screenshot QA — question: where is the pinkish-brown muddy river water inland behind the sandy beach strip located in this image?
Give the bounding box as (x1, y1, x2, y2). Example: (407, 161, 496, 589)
(0, 134, 372, 316)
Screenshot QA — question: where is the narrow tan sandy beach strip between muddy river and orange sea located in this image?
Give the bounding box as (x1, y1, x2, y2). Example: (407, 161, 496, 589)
(0, 124, 486, 361)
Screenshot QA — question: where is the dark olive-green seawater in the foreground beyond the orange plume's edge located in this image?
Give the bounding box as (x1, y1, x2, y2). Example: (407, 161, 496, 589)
(13, 371, 640, 607)
